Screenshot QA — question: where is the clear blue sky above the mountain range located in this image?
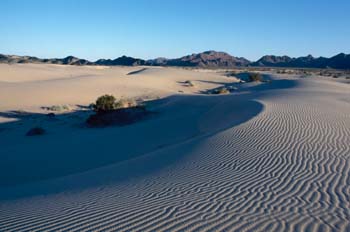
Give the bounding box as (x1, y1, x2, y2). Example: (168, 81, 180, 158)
(0, 0, 350, 60)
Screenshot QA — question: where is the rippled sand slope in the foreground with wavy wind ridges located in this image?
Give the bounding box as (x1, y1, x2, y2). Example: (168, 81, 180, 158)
(0, 83, 350, 232)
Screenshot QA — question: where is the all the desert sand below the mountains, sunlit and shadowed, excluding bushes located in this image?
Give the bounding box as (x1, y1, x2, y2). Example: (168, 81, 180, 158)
(0, 64, 350, 231)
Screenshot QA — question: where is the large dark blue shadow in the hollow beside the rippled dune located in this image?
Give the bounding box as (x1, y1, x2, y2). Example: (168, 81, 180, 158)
(0, 81, 294, 199)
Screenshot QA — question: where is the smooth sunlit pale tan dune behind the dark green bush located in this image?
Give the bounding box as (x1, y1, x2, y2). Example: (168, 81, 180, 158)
(0, 64, 238, 114)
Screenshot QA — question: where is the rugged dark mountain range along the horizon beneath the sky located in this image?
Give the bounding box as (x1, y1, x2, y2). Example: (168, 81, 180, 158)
(0, 51, 350, 69)
